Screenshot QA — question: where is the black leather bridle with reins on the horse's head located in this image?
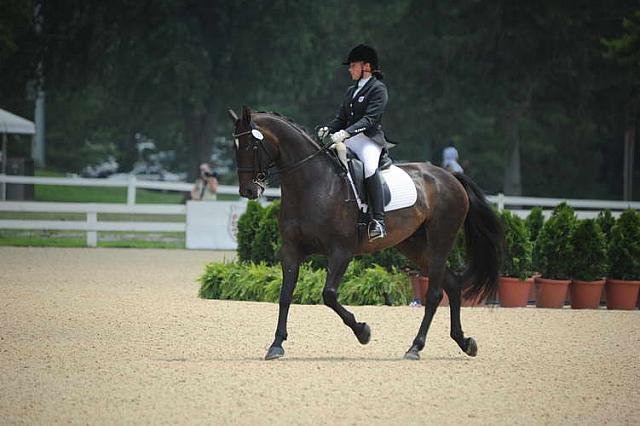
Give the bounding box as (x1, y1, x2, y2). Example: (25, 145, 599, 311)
(233, 121, 331, 190)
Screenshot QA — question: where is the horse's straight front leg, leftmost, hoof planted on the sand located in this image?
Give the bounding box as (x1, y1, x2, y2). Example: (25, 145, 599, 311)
(264, 249, 300, 360)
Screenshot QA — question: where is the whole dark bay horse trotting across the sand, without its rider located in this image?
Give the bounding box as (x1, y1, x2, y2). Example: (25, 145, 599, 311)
(229, 107, 502, 359)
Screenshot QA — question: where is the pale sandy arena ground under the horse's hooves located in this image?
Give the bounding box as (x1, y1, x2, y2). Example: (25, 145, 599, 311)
(0, 247, 640, 425)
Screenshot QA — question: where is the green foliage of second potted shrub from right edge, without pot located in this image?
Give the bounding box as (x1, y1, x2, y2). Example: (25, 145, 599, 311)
(571, 219, 607, 281)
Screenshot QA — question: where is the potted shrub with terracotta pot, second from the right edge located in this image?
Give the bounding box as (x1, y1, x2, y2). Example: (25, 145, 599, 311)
(570, 219, 607, 309)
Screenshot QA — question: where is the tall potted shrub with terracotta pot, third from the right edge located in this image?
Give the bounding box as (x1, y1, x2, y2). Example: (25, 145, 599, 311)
(534, 203, 576, 308)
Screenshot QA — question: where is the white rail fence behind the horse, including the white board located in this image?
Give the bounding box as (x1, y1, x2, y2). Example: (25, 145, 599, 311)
(0, 174, 640, 249)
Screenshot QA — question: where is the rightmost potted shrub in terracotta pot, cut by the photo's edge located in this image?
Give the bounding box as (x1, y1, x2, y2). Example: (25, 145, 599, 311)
(606, 209, 640, 309)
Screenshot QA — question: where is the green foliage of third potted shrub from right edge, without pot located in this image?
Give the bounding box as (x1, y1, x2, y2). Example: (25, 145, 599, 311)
(533, 203, 576, 280)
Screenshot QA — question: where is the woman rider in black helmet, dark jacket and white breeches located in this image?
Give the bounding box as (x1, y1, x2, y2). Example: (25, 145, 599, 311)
(318, 44, 389, 241)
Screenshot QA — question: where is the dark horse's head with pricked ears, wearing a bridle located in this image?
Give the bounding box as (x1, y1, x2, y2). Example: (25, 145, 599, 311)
(228, 106, 275, 200)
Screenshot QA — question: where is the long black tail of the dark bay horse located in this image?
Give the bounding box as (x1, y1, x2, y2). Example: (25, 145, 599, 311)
(454, 173, 503, 298)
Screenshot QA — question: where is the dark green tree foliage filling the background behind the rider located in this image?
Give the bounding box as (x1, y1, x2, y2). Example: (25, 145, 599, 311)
(0, 0, 640, 198)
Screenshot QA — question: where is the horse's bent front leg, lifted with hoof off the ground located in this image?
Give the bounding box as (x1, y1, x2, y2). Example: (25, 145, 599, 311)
(322, 252, 371, 345)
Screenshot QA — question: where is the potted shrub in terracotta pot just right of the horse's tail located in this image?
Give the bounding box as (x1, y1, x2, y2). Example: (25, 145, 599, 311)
(498, 210, 533, 308)
